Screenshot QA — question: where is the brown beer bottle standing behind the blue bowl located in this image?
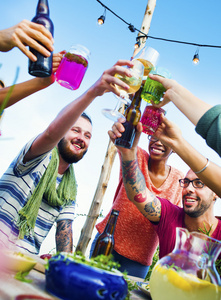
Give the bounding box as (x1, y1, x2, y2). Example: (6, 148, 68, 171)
(92, 209, 119, 257)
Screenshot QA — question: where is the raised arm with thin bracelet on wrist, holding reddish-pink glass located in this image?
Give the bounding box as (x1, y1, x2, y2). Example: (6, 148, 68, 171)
(154, 115, 221, 197)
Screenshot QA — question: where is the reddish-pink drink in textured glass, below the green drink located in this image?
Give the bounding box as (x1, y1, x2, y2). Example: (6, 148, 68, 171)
(140, 105, 166, 135)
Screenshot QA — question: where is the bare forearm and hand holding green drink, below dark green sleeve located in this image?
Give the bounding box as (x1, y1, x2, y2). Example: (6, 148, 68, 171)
(149, 74, 212, 126)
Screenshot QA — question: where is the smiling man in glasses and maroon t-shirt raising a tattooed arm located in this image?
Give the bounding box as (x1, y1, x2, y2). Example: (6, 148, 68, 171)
(109, 118, 221, 258)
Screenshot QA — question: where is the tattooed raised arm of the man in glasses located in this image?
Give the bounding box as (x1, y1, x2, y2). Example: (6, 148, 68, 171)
(108, 122, 161, 222)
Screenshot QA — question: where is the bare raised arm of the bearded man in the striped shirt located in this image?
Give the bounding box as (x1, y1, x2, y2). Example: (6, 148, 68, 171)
(25, 60, 133, 161)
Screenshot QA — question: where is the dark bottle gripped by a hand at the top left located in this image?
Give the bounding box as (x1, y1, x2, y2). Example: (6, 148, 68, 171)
(28, 0, 54, 77)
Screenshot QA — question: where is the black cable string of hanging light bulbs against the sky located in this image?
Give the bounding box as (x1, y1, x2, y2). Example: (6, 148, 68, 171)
(96, 0, 221, 65)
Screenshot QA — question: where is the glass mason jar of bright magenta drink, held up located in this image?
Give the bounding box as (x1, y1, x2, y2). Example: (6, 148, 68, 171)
(56, 45, 90, 90)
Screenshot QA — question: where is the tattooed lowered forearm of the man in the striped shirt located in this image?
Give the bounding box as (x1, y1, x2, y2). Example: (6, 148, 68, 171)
(55, 220, 73, 252)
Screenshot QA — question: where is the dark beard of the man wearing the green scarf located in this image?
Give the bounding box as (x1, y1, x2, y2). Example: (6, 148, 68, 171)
(58, 138, 87, 164)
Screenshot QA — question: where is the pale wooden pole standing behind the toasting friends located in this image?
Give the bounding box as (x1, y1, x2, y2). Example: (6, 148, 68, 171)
(75, 0, 156, 255)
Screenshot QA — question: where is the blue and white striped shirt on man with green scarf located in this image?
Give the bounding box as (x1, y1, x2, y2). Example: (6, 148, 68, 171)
(0, 139, 75, 254)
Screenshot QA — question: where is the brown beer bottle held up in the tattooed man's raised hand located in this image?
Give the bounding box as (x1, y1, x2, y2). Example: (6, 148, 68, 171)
(115, 85, 143, 149)
